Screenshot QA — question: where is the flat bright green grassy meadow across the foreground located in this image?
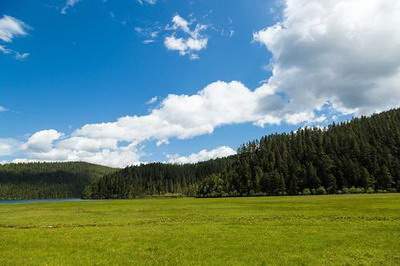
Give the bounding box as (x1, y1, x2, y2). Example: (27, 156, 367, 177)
(0, 194, 400, 265)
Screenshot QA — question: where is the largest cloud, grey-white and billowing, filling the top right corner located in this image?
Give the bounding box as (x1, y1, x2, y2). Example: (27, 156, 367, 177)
(254, 0, 400, 114)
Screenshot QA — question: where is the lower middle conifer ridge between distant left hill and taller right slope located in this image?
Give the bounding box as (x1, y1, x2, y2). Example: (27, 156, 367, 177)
(86, 157, 234, 199)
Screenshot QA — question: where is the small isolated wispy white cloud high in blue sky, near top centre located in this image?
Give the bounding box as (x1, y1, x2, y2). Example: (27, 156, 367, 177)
(164, 15, 208, 59)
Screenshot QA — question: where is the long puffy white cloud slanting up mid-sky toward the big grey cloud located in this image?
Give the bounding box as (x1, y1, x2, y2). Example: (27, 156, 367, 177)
(73, 81, 306, 143)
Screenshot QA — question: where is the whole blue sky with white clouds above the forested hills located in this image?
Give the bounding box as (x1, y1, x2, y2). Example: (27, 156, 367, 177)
(0, 0, 400, 167)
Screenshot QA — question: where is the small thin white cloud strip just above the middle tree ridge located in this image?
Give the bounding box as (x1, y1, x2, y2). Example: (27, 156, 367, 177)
(167, 146, 236, 164)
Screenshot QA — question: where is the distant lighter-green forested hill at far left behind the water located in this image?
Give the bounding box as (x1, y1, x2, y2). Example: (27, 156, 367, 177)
(0, 162, 116, 199)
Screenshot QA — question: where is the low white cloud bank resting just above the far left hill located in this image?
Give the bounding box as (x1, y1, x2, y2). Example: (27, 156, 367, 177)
(13, 129, 140, 167)
